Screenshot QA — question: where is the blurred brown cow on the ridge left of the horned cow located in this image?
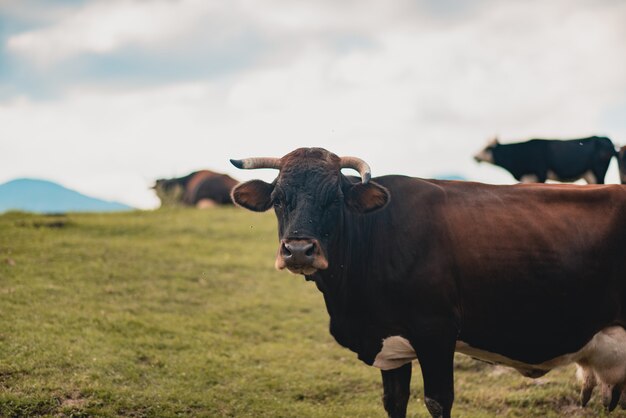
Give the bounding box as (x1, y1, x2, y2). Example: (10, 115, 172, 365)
(153, 170, 238, 207)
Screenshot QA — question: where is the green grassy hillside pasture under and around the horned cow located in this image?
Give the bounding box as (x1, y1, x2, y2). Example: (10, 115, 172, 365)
(0, 208, 626, 417)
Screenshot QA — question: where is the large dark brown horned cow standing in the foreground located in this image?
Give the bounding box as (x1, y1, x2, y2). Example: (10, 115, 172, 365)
(231, 148, 626, 417)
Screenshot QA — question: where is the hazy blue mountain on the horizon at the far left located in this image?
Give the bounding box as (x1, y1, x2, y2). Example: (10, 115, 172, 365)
(0, 179, 133, 213)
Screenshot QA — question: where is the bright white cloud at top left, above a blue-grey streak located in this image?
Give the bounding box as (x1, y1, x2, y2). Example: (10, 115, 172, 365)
(7, 0, 236, 68)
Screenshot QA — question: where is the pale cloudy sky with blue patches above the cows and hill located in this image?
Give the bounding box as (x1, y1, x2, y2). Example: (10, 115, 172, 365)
(0, 0, 626, 209)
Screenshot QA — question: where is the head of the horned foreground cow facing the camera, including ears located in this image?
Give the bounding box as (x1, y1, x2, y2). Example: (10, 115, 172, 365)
(231, 148, 389, 275)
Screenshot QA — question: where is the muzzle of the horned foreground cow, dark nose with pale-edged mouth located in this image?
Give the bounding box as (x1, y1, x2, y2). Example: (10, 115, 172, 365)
(275, 239, 328, 275)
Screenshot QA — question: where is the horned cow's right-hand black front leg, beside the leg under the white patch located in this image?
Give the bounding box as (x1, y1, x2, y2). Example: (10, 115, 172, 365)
(412, 336, 456, 418)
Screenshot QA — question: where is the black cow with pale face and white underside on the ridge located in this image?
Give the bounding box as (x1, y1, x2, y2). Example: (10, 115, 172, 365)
(474, 136, 615, 184)
